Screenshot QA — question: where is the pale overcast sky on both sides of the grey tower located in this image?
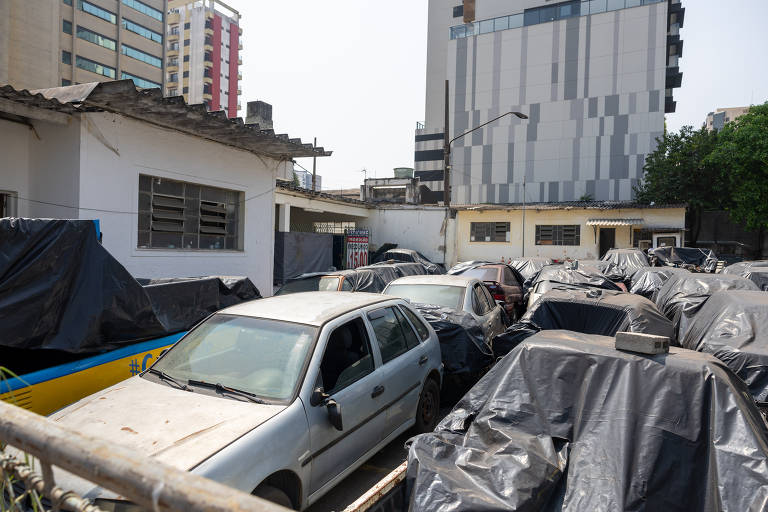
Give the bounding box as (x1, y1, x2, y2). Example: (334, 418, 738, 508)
(228, 0, 768, 189)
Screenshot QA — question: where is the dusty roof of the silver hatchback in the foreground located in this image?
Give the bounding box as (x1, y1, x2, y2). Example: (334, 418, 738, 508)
(219, 292, 393, 326)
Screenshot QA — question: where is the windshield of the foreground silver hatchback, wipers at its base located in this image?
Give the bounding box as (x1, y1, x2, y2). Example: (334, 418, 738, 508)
(152, 315, 317, 401)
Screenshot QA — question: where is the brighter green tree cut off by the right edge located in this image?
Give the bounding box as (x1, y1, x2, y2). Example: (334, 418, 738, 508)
(707, 102, 768, 231)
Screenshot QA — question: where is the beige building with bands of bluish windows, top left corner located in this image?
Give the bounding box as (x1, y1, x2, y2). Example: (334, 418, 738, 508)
(0, 0, 167, 89)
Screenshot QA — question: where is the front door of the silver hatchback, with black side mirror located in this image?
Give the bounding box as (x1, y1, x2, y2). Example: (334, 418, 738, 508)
(305, 316, 386, 494)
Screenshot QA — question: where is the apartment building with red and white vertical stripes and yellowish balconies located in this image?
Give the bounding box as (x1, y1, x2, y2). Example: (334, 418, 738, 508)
(166, 0, 243, 117)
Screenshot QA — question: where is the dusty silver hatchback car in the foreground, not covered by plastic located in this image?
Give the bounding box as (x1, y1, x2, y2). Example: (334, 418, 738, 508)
(52, 292, 442, 510)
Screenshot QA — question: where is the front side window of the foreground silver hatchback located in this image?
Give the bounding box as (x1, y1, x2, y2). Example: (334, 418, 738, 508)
(320, 317, 373, 395)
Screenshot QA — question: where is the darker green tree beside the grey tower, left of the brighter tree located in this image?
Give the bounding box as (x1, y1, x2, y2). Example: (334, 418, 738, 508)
(635, 126, 730, 243)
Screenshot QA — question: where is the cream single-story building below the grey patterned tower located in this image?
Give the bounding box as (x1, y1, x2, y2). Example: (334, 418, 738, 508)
(452, 201, 685, 261)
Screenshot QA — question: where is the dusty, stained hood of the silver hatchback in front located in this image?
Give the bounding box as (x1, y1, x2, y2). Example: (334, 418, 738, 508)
(50, 377, 285, 470)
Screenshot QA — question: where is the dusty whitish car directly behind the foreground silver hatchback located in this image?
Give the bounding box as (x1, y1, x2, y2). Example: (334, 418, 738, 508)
(383, 274, 506, 340)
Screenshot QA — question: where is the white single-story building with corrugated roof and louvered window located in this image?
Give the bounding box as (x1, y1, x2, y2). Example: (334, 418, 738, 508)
(0, 80, 330, 295)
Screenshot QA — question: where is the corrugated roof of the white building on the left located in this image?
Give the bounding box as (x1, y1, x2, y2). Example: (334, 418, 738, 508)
(0, 80, 331, 158)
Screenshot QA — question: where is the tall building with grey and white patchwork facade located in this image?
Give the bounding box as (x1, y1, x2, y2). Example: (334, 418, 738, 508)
(414, 0, 685, 204)
